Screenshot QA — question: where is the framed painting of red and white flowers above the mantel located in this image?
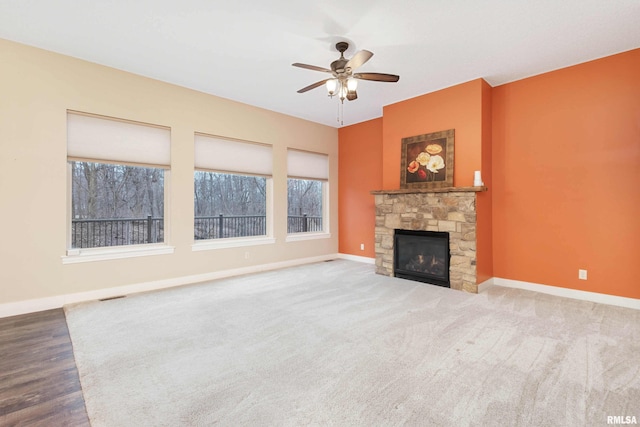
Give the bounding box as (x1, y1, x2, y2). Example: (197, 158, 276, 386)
(400, 129, 454, 188)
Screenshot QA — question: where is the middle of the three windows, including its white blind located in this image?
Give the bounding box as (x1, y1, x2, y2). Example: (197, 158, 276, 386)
(194, 134, 272, 241)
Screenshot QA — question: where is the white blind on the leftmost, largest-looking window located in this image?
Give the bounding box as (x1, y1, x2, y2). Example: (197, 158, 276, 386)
(67, 112, 171, 166)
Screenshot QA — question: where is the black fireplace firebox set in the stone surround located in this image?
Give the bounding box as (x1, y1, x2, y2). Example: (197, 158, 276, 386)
(393, 230, 451, 288)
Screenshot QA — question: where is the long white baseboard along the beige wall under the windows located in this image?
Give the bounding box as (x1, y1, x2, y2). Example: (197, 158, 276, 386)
(0, 254, 340, 318)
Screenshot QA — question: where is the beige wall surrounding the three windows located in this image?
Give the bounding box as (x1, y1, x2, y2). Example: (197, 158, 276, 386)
(0, 40, 338, 304)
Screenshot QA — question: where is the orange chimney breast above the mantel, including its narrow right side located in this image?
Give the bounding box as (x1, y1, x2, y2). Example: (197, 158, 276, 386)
(382, 79, 493, 283)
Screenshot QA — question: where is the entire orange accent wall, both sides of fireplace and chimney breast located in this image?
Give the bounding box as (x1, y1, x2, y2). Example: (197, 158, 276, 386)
(339, 49, 640, 298)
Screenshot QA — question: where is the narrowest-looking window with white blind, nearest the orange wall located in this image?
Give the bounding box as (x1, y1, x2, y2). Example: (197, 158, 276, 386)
(287, 150, 329, 234)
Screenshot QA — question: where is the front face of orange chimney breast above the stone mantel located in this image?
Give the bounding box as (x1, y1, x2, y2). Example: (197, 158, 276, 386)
(382, 79, 484, 190)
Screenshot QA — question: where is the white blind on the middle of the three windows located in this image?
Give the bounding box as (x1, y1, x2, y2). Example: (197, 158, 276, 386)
(195, 134, 273, 176)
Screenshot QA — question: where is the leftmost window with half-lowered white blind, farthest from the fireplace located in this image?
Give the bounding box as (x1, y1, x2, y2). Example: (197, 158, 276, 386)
(67, 112, 170, 249)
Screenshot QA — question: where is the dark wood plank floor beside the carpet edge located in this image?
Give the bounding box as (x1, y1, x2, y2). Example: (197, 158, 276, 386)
(0, 309, 90, 427)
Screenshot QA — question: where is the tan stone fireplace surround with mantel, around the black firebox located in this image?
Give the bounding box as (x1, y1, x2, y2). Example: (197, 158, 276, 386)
(372, 189, 482, 293)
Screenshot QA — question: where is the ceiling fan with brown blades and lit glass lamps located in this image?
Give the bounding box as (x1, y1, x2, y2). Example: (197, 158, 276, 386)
(291, 42, 400, 102)
